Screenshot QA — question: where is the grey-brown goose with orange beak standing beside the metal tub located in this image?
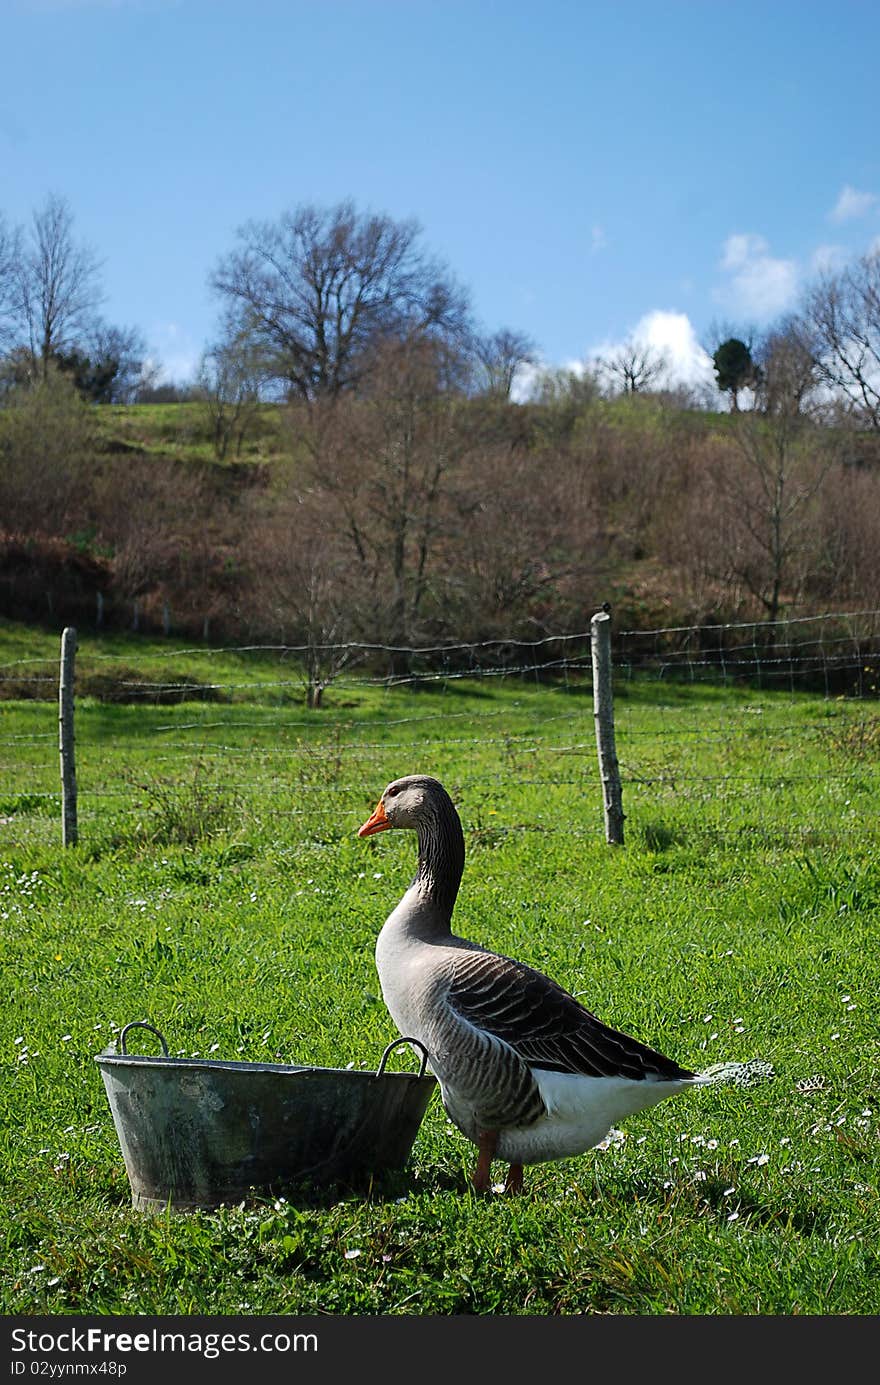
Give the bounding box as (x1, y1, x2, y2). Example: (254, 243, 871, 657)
(358, 774, 772, 1194)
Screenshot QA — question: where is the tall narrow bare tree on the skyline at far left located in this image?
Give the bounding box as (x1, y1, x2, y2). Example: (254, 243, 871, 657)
(18, 194, 101, 378)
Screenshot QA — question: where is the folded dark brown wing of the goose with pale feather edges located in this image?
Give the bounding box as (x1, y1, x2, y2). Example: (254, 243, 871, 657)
(446, 951, 694, 1082)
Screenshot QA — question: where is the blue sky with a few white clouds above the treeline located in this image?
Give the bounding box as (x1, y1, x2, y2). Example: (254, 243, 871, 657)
(0, 0, 880, 390)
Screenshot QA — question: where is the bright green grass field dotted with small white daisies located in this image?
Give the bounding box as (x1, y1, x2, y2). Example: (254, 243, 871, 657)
(0, 625, 880, 1316)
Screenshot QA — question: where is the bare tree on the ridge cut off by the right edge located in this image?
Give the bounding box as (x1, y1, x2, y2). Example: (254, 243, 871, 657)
(804, 249, 880, 429)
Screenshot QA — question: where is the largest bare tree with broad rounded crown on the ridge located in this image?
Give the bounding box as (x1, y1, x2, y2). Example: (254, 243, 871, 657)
(211, 202, 467, 400)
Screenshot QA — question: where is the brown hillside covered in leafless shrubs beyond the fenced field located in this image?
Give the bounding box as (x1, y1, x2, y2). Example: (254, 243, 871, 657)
(0, 379, 880, 645)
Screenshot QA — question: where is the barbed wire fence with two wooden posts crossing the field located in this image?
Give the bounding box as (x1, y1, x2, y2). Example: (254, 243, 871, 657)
(0, 611, 880, 843)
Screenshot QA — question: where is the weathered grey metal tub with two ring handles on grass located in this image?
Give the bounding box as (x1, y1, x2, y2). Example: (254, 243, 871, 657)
(94, 1019, 437, 1212)
